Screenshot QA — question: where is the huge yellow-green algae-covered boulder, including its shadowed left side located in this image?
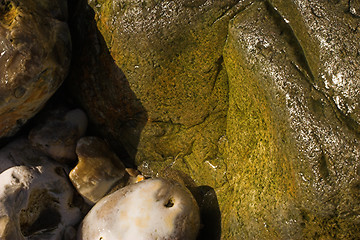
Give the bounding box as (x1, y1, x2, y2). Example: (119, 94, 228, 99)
(71, 0, 360, 239)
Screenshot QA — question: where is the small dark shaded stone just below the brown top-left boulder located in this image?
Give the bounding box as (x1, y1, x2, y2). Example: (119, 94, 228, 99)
(29, 109, 87, 162)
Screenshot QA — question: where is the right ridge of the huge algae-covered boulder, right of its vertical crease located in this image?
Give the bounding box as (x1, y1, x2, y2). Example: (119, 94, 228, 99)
(224, 1, 360, 239)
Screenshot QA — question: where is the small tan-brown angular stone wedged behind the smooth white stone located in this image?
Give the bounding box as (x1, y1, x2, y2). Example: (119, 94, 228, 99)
(69, 137, 128, 205)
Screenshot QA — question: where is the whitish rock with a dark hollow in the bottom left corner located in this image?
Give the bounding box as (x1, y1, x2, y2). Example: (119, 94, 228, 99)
(0, 139, 80, 240)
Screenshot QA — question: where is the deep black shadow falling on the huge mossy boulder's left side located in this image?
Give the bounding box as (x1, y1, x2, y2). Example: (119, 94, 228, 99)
(65, 0, 147, 167)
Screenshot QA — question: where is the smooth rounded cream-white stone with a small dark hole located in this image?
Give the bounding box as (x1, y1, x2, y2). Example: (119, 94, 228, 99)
(78, 178, 200, 240)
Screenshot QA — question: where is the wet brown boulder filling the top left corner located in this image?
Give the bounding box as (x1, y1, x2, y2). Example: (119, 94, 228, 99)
(0, 0, 71, 138)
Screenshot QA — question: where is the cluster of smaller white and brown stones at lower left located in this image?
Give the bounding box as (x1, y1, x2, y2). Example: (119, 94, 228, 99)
(0, 109, 200, 240)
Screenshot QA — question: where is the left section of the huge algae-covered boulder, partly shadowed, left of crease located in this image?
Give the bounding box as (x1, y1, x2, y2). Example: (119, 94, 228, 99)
(70, 0, 243, 184)
